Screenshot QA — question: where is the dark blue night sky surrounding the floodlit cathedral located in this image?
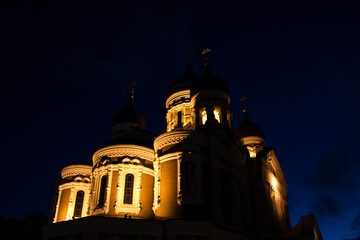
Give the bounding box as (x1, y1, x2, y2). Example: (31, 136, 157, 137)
(0, 0, 360, 240)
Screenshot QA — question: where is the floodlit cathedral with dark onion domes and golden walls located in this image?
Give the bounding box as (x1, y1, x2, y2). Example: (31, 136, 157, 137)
(43, 53, 322, 240)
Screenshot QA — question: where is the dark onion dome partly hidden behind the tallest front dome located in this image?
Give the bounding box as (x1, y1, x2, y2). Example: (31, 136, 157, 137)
(166, 63, 198, 98)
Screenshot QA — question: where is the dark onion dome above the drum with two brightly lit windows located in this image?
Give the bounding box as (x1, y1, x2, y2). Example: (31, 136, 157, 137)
(191, 65, 229, 95)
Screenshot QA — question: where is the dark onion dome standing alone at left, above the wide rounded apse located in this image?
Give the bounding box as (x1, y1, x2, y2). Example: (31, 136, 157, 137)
(112, 97, 146, 129)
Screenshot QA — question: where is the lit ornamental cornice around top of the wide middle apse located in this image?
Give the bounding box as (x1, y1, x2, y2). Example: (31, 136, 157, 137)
(93, 144, 155, 166)
